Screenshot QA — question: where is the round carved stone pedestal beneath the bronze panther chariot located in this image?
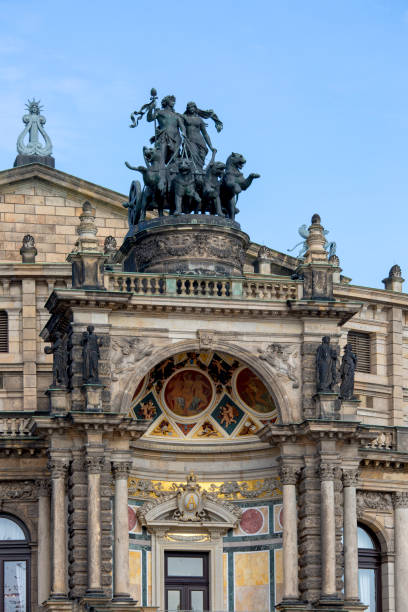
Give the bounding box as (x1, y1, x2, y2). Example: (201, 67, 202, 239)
(117, 215, 249, 276)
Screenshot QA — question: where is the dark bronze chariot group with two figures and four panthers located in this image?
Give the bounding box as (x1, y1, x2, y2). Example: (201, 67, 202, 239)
(124, 88, 259, 229)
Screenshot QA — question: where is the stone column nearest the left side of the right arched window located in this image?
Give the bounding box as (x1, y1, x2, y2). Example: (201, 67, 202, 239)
(343, 470, 359, 602)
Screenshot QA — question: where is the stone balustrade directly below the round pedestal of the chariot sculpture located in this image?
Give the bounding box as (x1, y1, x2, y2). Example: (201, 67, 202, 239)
(106, 272, 302, 302)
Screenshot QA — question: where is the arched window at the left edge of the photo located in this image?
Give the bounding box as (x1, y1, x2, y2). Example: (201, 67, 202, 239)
(0, 514, 30, 612)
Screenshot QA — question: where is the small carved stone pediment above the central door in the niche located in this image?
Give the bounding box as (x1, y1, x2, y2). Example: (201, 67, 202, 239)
(137, 473, 242, 533)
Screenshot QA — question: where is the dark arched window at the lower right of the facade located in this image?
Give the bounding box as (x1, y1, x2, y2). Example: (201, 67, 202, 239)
(358, 525, 382, 612)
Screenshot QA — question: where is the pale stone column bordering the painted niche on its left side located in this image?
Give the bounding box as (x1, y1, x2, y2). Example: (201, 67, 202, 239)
(112, 461, 132, 600)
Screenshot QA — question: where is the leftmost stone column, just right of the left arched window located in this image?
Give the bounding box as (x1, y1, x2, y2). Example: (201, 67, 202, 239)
(37, 480, 51, 605)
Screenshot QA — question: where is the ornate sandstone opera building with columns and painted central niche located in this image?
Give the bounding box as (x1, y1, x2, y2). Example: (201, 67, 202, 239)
(0, 101, 408, 612)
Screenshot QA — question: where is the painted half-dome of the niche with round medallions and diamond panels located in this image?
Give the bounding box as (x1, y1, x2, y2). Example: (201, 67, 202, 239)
(122, 343, 287, 442)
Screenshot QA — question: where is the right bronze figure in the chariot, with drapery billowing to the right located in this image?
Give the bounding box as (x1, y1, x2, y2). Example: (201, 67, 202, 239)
(182, 102, 222, 170)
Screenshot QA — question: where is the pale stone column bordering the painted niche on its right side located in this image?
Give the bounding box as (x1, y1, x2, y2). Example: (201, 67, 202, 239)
(280, 465, 299, 601)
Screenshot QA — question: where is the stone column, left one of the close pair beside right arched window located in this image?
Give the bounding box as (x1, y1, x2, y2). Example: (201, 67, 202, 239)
(320, 463, 337, 599)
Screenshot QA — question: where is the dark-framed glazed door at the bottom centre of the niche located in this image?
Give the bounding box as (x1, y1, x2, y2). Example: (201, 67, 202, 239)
(165, 551, 210, 612)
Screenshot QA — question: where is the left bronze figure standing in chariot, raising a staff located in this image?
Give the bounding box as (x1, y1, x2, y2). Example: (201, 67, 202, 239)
(146, 96, 185, 164)
